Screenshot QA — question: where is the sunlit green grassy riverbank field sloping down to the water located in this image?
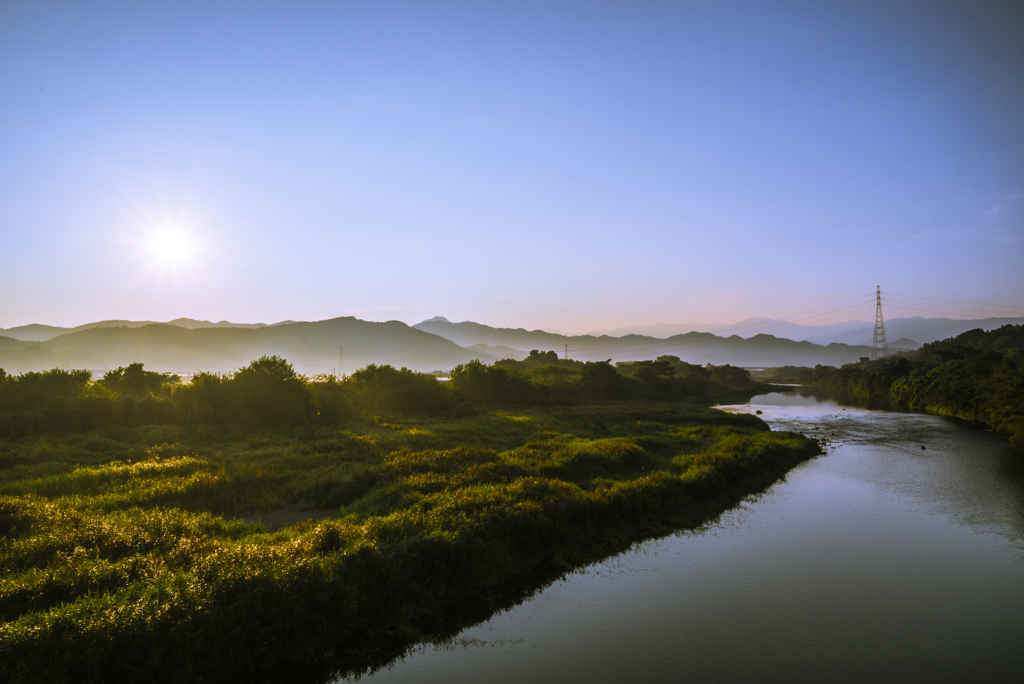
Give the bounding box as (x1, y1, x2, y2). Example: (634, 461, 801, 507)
(0, 401, 818, 682)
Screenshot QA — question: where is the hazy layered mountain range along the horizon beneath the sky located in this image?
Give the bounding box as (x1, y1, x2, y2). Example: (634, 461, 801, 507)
(0, 316, 1024, 375)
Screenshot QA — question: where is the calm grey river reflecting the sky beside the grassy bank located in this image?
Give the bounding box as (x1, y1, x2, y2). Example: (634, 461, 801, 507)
(342, 392, 1024, 684)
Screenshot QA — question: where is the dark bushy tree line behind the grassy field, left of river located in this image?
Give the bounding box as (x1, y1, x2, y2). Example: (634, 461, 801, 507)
(0, 350, 760, 436)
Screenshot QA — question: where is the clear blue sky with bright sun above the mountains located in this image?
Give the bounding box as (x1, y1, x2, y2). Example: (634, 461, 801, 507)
(0, 0, 1024, 332)
